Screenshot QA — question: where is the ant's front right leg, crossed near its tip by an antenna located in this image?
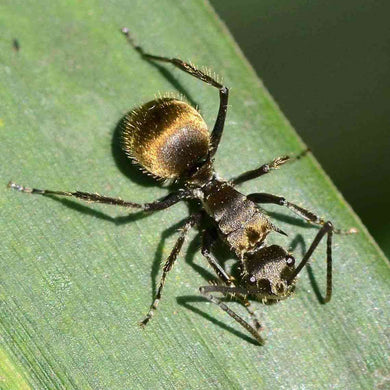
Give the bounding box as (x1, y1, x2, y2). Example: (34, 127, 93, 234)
(247, 192, 357, 234)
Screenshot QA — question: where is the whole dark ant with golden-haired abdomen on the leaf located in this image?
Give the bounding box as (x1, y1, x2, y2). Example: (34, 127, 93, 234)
(8, 28, 355, 345)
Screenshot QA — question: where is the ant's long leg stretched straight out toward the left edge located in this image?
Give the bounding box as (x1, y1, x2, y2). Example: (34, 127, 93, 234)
(8, 181, 189, 211)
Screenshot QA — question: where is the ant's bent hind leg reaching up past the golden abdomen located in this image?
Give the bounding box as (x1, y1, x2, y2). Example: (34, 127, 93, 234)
(122, 27, 229, 157)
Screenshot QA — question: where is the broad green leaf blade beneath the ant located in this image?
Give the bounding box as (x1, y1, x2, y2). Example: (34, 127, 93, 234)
(0, 0, 389, 389)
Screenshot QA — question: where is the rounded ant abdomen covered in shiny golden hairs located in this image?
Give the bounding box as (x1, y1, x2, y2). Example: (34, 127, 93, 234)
(122, 98, 210, 179)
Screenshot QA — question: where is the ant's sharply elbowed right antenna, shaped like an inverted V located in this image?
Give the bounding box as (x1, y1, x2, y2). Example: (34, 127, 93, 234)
(287, 221, 334, 303)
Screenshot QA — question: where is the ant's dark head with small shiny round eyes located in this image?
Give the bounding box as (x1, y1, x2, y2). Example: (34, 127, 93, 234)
(243, 245, 295, 299)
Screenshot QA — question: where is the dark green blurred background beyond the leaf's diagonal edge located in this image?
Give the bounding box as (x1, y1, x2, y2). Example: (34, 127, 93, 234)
(211, 0, 390, 257)
